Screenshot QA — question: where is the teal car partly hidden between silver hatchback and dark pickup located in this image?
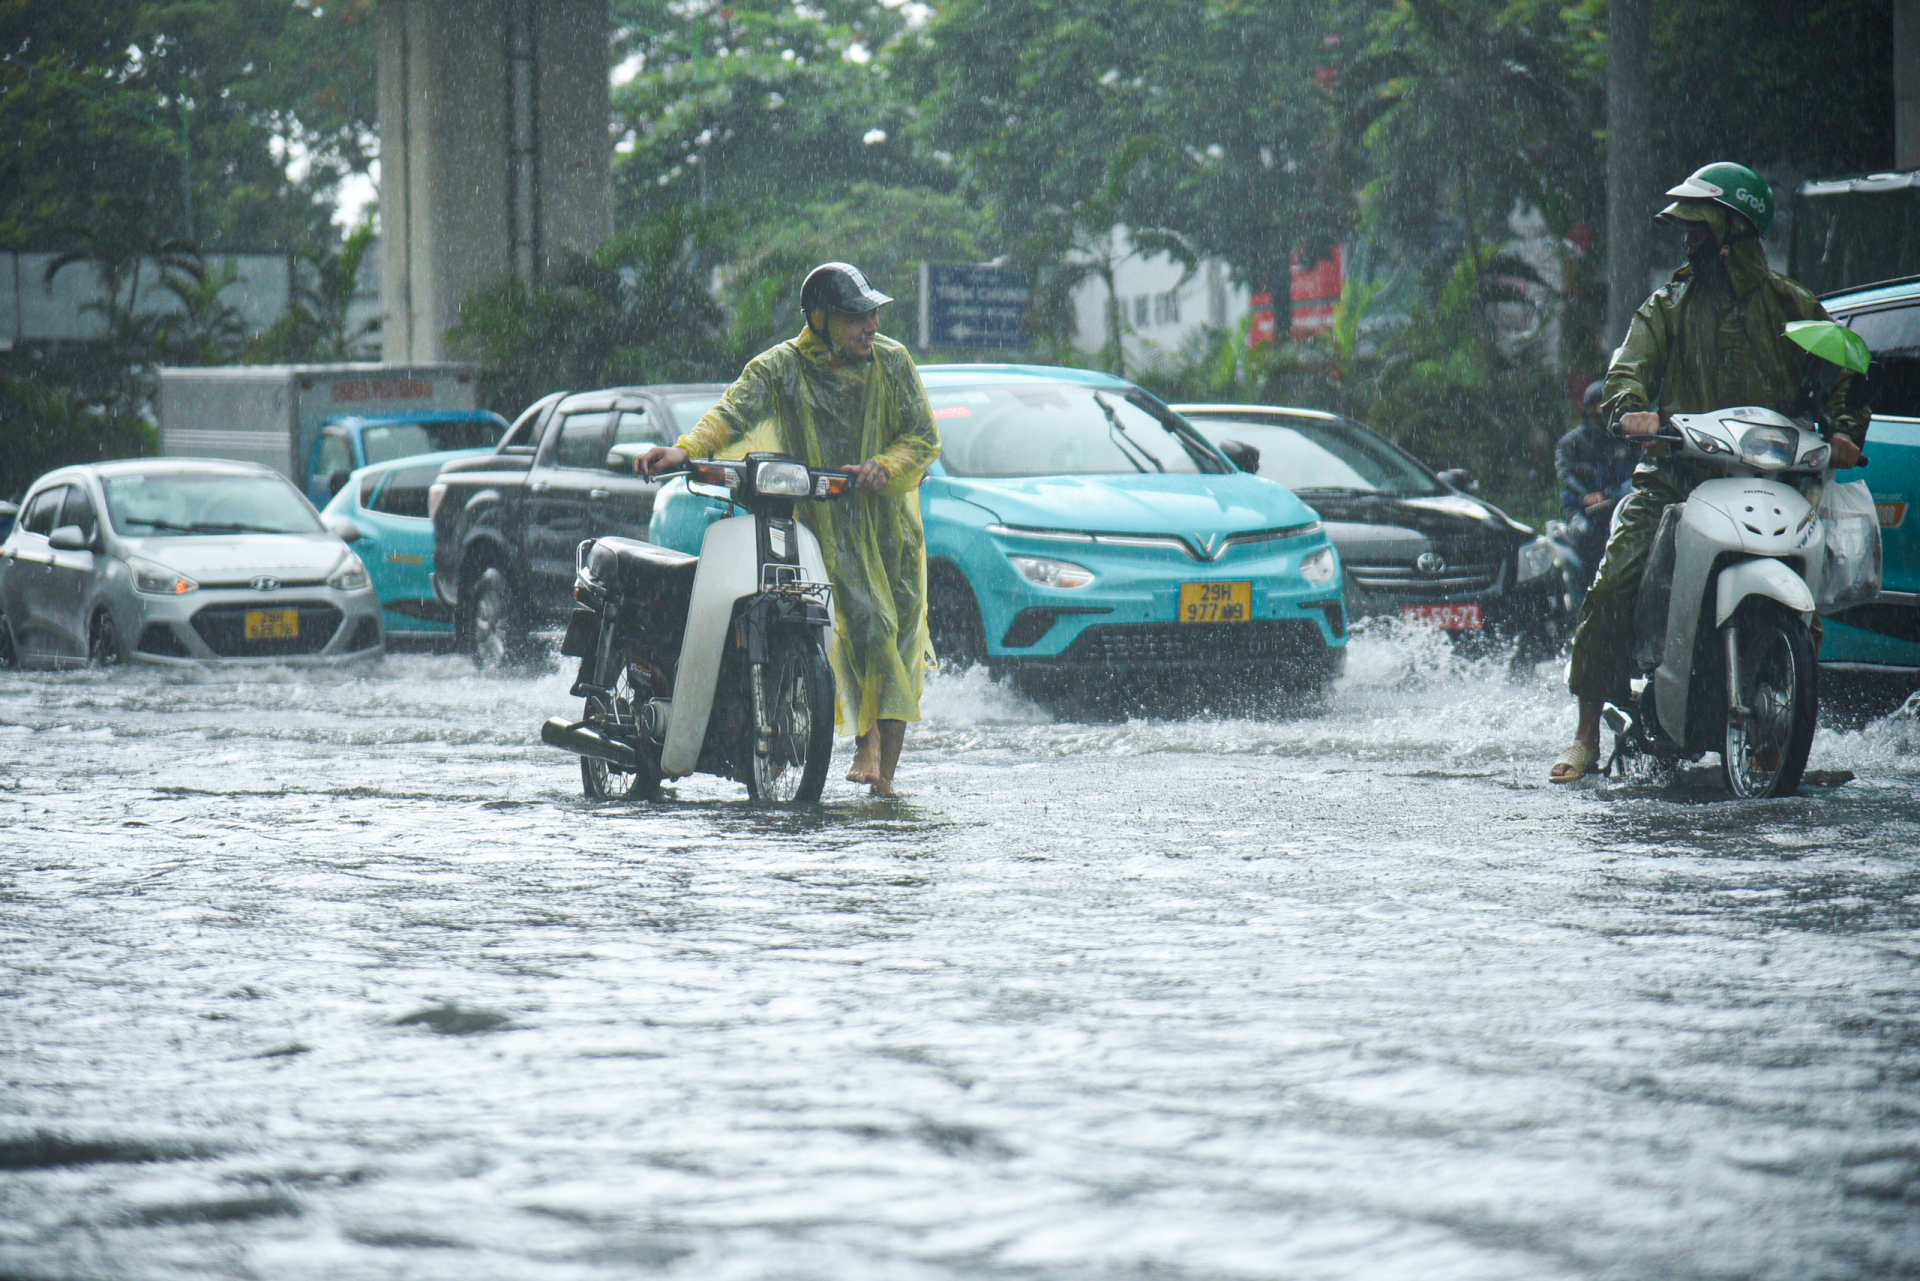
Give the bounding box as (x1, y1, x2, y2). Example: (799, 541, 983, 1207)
(321, 449, 492, 641)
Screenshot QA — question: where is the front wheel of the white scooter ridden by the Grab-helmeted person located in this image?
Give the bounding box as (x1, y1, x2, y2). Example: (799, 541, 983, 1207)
(1720, 601, 1818, 801)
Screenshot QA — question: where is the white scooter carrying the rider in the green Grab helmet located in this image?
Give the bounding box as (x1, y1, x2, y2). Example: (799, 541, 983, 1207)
(1605, 405, 1832, 797)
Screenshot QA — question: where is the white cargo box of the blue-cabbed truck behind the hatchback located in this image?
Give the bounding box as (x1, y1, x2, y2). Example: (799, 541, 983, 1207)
(159, 363, 497, 501)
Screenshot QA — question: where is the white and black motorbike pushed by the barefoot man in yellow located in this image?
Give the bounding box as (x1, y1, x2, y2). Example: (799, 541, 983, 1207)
(540, 446, 852, 805)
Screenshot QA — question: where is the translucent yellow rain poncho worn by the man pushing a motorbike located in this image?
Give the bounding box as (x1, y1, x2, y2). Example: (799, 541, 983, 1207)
(676, 330, 941, 734)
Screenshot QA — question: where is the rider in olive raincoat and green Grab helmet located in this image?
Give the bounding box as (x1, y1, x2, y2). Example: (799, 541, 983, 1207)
(1548, 161, 1866, 784)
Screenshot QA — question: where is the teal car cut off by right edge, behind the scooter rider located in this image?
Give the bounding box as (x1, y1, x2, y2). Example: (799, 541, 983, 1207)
(1820, 277, 1920, 688)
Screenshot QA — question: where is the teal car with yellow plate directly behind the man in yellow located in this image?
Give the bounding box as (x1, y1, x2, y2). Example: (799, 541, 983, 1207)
(649, 365, 1346, 707)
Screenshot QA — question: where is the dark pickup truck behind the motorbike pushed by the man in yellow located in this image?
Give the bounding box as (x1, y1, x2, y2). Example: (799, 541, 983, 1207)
(426, 382, 726, 666)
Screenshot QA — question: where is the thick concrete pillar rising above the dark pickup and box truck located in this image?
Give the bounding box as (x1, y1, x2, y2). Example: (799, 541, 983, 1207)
(380, 0, 612, 365)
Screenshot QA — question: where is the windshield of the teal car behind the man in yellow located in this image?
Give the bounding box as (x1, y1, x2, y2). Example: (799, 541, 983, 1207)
(927, 382, 1227, 476)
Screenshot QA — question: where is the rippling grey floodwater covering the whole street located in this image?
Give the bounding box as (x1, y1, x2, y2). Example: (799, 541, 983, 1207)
(0, 634, 1920, 1281)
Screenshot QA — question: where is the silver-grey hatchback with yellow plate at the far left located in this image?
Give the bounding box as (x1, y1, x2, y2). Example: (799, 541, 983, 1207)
(0, 459, 384, 666)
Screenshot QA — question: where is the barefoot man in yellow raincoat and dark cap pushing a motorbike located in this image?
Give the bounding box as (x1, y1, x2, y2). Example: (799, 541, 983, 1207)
(636, 263, 941, 797)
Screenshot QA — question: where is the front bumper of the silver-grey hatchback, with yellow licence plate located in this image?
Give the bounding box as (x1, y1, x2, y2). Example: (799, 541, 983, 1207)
(127, 584, 386, 663)
